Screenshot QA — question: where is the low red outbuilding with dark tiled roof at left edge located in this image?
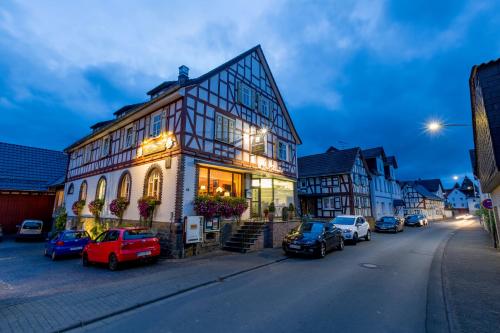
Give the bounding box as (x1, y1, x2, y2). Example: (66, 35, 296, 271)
(0, 142, 68, 233)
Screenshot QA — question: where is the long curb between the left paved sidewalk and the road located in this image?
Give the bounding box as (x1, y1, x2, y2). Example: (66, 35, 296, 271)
(53, 258, 288, 332)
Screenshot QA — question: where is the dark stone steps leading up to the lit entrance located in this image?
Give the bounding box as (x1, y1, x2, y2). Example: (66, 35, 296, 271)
(222, 222, 266, 253)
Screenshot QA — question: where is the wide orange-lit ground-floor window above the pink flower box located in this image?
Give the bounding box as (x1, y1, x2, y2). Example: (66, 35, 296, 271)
(198, 167, 242, 197)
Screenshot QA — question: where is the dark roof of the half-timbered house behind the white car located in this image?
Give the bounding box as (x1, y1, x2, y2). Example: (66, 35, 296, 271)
(298, 148, 361, 177)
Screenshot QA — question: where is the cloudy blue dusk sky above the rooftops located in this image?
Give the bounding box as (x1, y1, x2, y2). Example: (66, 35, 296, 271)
(0, 0, 500, 186)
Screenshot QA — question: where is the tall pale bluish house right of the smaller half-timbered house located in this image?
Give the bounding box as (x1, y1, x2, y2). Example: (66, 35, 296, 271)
(362, 147, 404, 219)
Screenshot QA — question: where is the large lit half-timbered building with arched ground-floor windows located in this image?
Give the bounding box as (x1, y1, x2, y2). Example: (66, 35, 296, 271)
(66, 46, 301, 253)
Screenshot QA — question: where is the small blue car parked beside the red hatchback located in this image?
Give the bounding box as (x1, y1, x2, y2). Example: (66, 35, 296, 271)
(44, 230, 90, 260)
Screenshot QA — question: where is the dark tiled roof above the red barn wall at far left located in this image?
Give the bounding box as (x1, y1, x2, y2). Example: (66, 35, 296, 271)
(0, 142, 68, 191)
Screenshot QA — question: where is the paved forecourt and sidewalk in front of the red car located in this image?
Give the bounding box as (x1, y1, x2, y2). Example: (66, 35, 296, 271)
(0, 249, 284, 333)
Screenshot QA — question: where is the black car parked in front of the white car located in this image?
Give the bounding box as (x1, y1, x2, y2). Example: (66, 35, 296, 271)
(282, 221, 344, 258)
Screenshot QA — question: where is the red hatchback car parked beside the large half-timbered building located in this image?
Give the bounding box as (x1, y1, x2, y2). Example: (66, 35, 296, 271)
(82, 228, 160, 271)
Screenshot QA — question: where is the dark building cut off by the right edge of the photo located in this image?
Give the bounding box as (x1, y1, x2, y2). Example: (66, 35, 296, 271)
(469, 58, 500, 240)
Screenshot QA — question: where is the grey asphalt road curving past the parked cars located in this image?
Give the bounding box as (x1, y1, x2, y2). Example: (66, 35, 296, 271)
(75, 222, 466, 333)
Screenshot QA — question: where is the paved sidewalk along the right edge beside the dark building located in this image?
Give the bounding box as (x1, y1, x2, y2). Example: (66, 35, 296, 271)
(442, 222, 500, 333)
